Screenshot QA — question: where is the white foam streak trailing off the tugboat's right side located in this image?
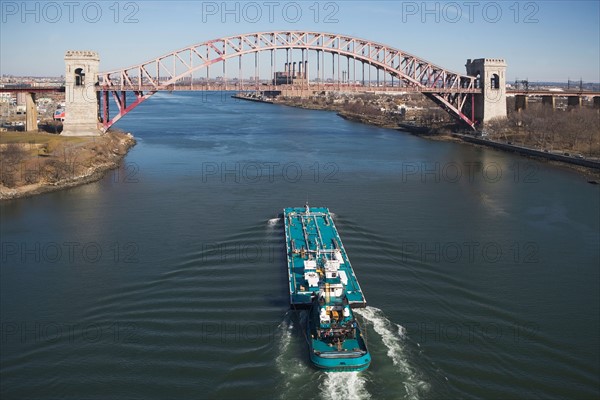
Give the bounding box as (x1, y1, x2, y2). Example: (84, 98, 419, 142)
(355, 306, 429, 400)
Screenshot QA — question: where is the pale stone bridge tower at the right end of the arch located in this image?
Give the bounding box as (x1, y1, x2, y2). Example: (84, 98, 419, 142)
(466, 58, 506, 125)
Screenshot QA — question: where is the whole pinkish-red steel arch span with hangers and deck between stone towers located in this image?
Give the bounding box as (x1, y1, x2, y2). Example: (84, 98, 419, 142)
(96, 31, 482, 131)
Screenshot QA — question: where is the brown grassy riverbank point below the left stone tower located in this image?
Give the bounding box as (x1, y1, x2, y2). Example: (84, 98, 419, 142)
(0, 131, 136, 200)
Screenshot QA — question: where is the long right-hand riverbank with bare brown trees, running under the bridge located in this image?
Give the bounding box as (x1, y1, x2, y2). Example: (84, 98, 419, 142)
(237, 93, 600, 177)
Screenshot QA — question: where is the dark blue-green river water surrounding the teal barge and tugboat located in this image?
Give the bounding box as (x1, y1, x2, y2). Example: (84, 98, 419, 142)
(0, 93, 600, 400)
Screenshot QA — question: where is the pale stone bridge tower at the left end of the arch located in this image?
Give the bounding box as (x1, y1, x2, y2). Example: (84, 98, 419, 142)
(62, 50, 101, 136)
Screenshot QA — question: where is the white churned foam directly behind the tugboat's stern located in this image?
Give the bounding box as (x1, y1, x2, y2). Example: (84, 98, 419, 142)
(320, 372, 371, 400)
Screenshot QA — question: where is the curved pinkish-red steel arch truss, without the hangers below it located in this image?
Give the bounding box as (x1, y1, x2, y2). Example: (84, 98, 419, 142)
(98, 31, 481, 130)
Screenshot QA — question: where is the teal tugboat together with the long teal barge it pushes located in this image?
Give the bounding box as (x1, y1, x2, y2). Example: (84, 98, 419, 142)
(283, 204, 371, 371)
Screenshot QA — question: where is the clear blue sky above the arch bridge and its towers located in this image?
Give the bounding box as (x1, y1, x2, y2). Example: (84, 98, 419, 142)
(0, 0, 600, 82)
